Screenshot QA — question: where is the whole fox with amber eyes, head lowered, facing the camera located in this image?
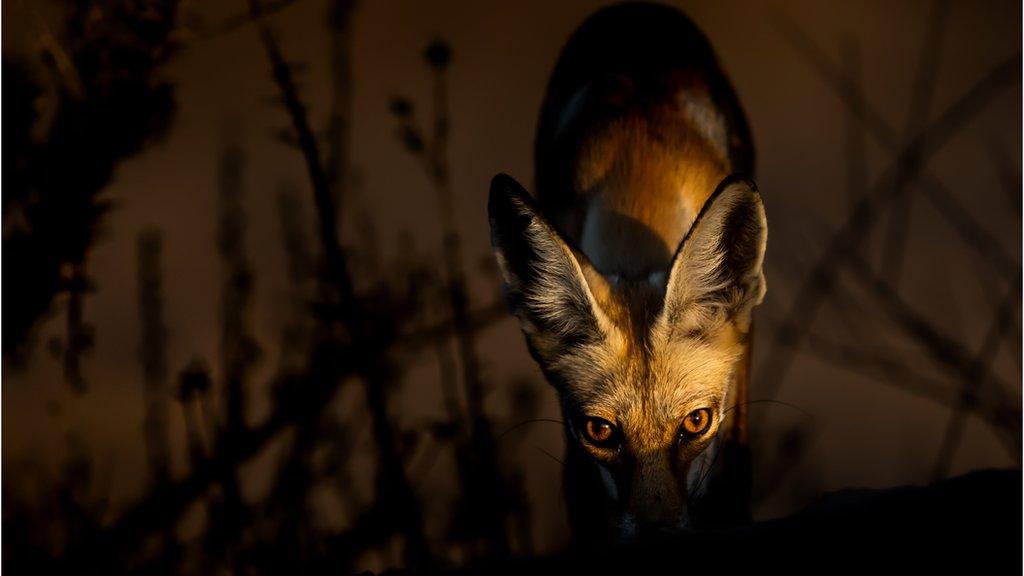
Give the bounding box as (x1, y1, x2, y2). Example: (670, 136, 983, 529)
(487, 3, 767, 545)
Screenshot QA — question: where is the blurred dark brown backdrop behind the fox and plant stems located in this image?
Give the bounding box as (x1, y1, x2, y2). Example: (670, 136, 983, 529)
(2, 0, 1022, 570)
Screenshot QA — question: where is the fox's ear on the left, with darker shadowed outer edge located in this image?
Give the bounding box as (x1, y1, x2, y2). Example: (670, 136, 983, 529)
(487, 174, 607, 360)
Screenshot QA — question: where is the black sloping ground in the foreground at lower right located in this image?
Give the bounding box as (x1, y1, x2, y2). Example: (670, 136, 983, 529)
(446, 470, 1022, 576)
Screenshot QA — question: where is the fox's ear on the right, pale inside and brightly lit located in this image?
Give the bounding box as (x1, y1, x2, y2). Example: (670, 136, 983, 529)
(662, 177, 768, 333)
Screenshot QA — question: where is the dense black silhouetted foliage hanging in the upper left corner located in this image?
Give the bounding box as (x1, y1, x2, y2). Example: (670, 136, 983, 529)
(3, 0, 179, 379)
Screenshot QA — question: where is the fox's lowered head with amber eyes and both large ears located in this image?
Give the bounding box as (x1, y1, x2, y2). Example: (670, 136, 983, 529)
(488, 170, 767, 537)
